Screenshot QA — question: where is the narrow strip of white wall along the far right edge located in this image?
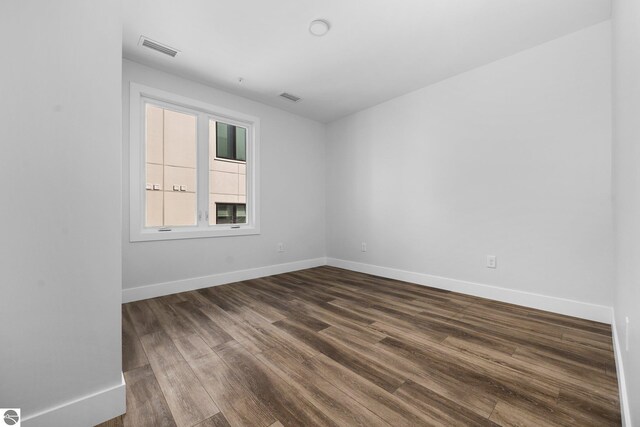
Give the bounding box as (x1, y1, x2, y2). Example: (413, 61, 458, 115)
(613, 0, 640, 425)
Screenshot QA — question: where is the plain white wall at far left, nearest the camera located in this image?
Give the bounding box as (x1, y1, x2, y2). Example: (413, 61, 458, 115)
(0, 0, 124, 426)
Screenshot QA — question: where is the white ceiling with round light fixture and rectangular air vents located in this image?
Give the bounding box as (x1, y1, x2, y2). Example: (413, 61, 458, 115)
(123, 0, 611, 122)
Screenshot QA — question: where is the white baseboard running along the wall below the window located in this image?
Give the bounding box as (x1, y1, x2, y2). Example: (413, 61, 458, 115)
(122, 258, 327, 303)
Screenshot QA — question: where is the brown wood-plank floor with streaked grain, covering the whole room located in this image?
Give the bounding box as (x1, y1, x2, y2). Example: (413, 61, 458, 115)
(99, 267, 621, 427)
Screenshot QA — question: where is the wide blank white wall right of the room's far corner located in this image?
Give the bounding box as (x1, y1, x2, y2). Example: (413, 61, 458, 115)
(327, 22, 613, 306)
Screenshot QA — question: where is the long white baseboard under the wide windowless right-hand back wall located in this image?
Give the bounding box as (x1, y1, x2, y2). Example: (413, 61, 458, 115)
(327, 258, 612, 324)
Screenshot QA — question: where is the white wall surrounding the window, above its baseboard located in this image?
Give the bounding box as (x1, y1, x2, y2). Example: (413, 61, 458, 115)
(122, 60, 325, 291)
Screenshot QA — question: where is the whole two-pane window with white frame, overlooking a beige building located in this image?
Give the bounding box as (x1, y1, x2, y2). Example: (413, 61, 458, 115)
(130, 83, 259, 241)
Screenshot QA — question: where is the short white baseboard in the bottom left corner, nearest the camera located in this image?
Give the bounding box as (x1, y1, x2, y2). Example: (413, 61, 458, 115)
(22, 375, 127, 427)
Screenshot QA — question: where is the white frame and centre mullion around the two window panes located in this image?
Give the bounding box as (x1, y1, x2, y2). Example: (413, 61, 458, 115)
(129, 82, 260, 242)
